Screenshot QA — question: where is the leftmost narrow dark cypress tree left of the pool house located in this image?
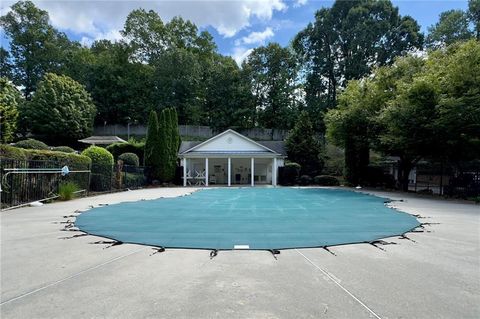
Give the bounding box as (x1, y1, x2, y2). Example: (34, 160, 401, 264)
(144, 111, 160, 180)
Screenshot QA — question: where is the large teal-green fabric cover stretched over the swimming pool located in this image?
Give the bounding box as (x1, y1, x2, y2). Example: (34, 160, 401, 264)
(75, 188, 420, 250)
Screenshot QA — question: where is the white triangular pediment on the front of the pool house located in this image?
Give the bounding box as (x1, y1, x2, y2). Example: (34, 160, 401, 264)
(184, 130, 275, 154)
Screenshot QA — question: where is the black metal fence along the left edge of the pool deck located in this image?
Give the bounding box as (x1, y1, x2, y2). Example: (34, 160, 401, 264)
(0, 159, 147, 209)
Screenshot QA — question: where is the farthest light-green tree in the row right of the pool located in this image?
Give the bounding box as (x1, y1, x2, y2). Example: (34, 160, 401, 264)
(326, 56, 425, 185)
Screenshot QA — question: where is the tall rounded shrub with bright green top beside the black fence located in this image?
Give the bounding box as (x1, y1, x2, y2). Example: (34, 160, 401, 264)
(82, 145, 114, 191)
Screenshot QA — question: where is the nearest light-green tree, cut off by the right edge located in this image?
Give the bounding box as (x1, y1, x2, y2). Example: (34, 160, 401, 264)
(427, 40, 480, 163)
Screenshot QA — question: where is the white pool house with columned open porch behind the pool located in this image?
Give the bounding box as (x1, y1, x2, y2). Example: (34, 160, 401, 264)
(178, 129, 286, 186)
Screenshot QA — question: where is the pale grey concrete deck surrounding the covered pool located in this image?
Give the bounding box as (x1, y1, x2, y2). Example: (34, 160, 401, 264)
(0, 188, 480, 318)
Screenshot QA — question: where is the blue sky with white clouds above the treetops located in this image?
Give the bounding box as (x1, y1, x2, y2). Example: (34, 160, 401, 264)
(0, 0, 468, 62)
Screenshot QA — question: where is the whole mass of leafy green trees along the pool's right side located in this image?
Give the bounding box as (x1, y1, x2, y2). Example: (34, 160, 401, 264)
(327, 40, 480, 188)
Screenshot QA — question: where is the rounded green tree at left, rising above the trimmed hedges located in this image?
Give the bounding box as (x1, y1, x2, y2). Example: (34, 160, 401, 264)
(21, 73, 96, 144)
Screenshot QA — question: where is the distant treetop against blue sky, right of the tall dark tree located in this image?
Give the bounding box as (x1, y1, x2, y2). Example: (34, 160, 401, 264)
(426, 10, 473, 48)
